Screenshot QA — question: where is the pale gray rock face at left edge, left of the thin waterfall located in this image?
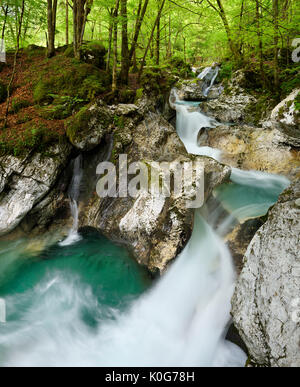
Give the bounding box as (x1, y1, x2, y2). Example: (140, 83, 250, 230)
(0, 145, 71, 235)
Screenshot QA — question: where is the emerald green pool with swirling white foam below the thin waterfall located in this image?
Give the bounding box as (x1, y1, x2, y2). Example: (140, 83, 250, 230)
(0, 232, 150, 366)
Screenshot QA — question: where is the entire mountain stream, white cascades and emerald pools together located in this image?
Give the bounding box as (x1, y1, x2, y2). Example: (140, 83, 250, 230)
(0, 74, 288, 367)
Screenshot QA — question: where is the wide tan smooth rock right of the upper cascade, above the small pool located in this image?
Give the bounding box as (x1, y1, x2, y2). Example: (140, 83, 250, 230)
(199, 125, 300, 180)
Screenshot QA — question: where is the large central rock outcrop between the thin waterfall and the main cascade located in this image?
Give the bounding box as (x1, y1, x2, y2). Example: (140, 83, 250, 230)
(81, 112, 231, 272)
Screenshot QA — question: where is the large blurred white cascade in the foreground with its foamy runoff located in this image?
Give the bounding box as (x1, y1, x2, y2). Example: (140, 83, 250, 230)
(0, 212, 246, 367)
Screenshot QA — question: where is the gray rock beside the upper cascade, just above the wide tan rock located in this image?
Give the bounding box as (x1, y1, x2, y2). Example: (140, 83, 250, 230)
(201, 91, 256, 123)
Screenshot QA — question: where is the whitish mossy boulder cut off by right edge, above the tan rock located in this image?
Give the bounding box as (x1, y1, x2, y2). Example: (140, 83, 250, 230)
(265, 89, 300, 146)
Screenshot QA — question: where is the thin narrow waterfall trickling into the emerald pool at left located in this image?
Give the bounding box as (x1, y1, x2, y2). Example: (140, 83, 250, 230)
(60, 155, 83, 246)
